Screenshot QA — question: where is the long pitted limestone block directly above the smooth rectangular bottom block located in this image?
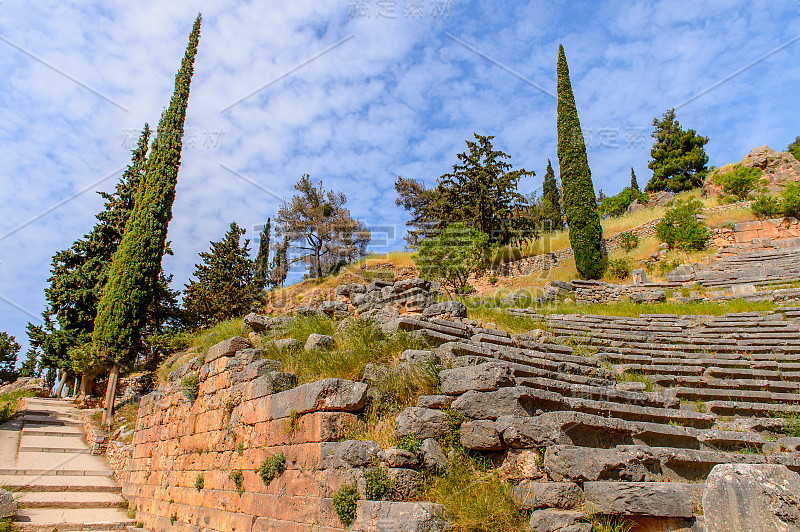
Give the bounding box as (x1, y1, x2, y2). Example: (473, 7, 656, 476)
(544, 445, 661, 482)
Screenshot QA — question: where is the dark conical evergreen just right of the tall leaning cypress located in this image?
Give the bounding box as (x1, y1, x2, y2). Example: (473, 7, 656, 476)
(183, 222, 254, 327)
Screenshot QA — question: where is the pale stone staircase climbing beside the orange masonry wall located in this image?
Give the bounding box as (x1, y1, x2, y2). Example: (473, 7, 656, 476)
(0, 398, 134, 532)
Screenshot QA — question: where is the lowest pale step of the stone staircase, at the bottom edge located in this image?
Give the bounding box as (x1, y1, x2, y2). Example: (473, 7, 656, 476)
(14, 508, 135, 532)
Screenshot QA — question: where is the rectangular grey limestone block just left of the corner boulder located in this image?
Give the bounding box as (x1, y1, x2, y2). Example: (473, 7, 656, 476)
(583, 482, 695, 517)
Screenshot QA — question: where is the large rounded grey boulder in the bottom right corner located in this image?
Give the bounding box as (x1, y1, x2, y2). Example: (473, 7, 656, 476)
(703, 464, 800, 532)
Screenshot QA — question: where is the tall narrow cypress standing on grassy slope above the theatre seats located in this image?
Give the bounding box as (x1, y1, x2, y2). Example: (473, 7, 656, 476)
(557, 45, 603, 279)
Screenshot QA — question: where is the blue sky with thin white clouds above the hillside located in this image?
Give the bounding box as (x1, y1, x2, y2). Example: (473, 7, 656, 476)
(0, 0, 800, 358)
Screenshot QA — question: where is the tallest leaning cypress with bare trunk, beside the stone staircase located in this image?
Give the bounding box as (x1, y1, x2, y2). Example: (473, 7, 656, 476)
(92, 15, 201, 423)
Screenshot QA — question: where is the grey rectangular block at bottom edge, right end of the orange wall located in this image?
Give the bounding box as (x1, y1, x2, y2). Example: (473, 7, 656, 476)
(352, 501, 450, 532)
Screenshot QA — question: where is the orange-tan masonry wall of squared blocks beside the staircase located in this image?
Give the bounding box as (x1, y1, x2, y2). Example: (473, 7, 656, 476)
(122, 339, 378, 532)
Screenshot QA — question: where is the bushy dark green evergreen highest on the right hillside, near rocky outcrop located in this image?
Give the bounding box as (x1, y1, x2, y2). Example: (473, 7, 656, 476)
(645, 109, 708, 193)
